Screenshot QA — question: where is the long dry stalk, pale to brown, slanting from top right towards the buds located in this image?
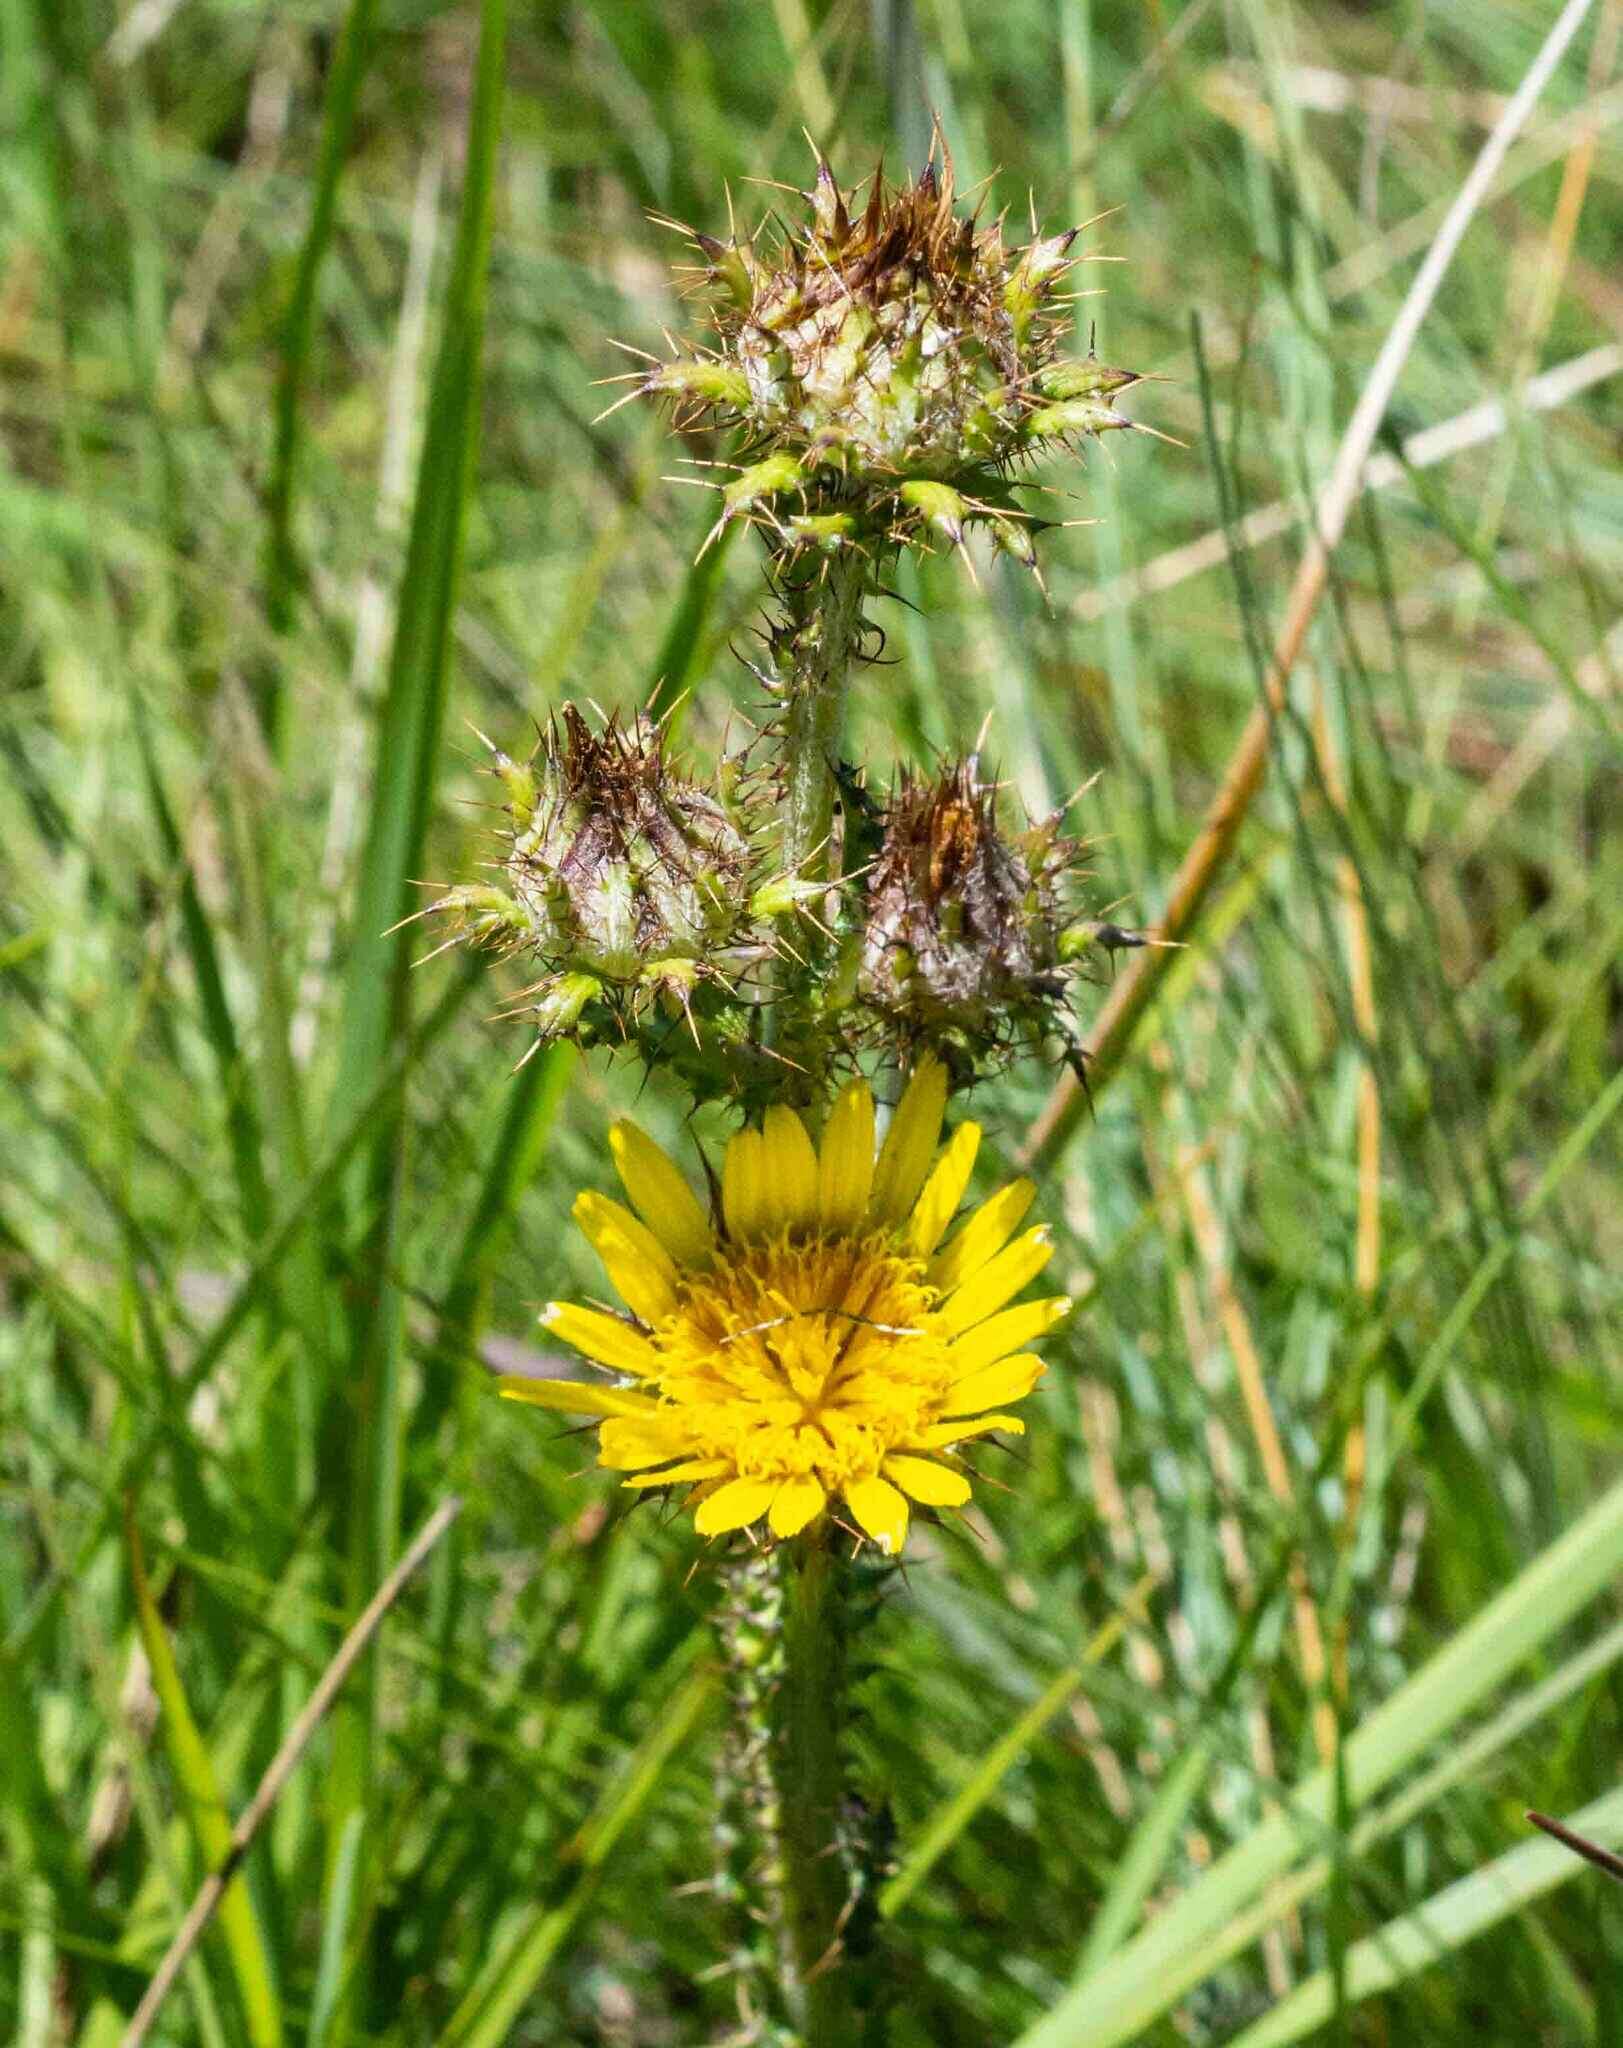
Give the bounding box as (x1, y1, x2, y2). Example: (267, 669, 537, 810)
(1025, 0, 1592, 1165)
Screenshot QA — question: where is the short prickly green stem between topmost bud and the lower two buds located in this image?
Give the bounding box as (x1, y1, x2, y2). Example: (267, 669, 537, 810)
(773, 549, 869, 879)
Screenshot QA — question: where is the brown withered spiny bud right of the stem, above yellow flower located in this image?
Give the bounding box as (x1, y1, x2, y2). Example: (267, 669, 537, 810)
(859, 756, 1086, 1079)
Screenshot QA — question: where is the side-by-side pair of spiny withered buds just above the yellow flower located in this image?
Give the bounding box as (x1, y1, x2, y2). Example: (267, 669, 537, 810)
(430, 724, 1113, 1108)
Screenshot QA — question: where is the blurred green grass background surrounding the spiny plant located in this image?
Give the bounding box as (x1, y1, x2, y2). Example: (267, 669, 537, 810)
(0, 0, 1623, 2048)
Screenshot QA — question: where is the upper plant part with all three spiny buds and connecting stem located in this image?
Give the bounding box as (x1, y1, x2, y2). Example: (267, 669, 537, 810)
(434, 137, 1137, 1116)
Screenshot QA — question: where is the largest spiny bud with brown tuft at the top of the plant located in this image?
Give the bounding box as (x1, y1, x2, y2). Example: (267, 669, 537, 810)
(614, 133, 1139, 565)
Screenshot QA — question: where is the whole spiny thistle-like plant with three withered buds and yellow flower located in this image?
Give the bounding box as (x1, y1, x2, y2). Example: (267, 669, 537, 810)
(436, 145, 1137, 2048)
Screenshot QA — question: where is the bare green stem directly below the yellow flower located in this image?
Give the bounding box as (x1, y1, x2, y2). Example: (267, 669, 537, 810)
(771, 1530, 859, 2048)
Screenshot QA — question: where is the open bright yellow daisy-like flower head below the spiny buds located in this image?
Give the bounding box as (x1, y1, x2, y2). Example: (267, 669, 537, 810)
(500, 1061, 1070, 1554)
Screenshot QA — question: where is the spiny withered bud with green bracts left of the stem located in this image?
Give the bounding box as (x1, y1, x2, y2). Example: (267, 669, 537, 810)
(432, 705, 778, 1042)
